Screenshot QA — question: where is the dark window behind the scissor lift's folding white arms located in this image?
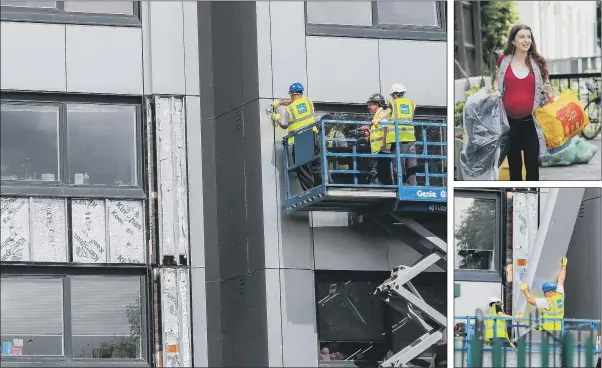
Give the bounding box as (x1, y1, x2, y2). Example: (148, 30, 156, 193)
(315, 271, 447, 362)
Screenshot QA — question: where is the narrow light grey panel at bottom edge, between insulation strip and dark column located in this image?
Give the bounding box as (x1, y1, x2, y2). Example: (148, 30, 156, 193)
(190, 267, 208, 367)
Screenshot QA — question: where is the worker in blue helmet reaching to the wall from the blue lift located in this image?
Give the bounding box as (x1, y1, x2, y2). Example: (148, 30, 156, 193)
(272, 82, 318, 191)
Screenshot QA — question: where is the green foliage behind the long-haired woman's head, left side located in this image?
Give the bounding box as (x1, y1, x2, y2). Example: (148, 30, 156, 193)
(481, 0, 519, 74)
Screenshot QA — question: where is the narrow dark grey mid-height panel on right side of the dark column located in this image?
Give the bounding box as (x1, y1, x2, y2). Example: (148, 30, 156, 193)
(242, 100, 266, 272)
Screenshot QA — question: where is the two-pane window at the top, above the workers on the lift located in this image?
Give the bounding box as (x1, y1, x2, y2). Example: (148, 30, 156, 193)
(306, 1, 447, 41)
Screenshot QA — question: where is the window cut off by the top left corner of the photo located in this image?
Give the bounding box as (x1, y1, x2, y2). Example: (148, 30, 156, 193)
(0, 0, 141, 27)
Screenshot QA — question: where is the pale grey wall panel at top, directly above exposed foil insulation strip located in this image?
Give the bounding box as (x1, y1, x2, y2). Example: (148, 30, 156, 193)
(143, 1, 186, 95)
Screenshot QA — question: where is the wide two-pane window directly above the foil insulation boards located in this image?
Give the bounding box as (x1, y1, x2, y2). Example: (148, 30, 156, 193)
(0, 99, 142, 198)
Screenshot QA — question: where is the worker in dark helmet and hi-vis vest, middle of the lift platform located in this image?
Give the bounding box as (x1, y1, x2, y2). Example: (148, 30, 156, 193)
(364, 93, 392, 185)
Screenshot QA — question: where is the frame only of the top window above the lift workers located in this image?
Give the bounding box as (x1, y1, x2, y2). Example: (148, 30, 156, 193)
(304, 0, 447, 42)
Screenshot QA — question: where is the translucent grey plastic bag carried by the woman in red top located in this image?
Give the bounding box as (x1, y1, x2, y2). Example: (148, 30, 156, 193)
(460, 88, 510, 180)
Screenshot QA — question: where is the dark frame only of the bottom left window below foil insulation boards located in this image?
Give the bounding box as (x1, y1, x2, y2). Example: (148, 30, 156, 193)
(0, 265, 152, 368)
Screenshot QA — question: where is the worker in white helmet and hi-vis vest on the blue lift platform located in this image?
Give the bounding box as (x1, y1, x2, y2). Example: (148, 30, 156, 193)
(372, 83, 418, 185)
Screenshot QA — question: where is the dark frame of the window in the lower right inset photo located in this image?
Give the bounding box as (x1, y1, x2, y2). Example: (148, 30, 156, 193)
(453, 189, 505, 282)
